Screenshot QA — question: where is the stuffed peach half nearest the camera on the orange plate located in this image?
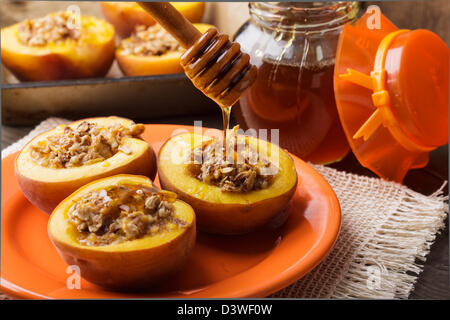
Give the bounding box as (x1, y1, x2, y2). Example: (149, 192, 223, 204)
(48, 175, 196, 291)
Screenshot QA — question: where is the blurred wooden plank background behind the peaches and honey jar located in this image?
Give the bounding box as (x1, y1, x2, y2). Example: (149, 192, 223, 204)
(0, 0, 450, 82)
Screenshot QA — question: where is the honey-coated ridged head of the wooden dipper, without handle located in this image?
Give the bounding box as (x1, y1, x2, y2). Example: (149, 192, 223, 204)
(180, 28, 257, 107)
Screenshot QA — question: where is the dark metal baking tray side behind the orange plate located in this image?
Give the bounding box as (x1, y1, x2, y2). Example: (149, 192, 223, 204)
(1, 74, 216, 125)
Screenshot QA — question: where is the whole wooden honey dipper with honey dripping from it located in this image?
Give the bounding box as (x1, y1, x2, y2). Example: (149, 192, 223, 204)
(139, 2, 257, 140)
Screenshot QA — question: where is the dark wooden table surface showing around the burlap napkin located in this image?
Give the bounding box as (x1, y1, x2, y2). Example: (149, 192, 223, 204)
(1, 113, 450, 299)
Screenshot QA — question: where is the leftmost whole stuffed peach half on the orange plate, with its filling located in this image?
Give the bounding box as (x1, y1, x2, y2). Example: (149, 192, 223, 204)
(15, 117, 156, 213)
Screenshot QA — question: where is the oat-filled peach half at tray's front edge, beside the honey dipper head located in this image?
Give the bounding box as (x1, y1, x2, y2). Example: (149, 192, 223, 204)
(116, 23, 213, 76)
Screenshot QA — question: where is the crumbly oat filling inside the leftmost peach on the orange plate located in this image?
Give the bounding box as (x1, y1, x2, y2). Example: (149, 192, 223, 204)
(30, 121, 145, 169)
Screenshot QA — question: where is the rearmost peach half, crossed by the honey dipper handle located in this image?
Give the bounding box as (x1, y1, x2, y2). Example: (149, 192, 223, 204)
(100, 2, 205, 38)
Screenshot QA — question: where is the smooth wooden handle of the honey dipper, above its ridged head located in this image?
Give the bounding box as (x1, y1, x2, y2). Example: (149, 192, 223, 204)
(138, 2, 201, 49)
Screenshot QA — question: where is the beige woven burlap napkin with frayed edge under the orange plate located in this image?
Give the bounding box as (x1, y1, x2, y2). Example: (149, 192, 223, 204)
(2, 118, 448, 298)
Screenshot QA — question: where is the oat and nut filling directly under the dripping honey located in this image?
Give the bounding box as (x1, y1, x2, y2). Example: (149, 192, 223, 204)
(187, 128, 279, 193)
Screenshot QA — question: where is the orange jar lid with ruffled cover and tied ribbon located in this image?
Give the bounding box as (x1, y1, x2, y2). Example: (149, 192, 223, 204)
(334, 8, 449, 182)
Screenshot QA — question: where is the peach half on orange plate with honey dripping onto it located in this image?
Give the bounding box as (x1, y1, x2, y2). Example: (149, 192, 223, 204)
(158, 130, 297, 234)
